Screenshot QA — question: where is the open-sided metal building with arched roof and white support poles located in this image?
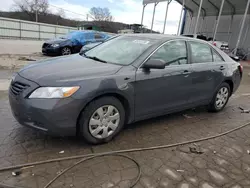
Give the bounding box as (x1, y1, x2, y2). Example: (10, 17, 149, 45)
(142, 0, 250, 58)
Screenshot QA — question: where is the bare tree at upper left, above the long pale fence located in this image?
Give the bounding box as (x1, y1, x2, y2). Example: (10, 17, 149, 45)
(14, 0, 49, 18)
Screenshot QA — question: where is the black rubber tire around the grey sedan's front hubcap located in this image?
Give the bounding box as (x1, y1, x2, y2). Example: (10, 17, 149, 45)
(79, 97, 125, 144)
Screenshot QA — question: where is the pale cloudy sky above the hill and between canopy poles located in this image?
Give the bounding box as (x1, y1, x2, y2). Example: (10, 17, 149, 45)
(0, 0, 181, 34)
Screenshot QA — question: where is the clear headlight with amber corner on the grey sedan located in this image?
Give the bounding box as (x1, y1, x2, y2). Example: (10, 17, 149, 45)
(29, 86, 80, 99)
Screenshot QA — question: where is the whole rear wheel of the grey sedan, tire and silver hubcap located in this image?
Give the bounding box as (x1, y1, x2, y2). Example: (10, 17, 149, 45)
(208, 83, 231, 112)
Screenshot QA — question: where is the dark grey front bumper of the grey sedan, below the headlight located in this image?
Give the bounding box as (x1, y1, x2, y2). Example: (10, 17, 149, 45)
(9, 75, 81, 136)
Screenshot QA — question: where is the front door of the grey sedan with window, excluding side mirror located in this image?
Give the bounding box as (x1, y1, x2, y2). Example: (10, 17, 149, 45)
(135, 40, 192, 119)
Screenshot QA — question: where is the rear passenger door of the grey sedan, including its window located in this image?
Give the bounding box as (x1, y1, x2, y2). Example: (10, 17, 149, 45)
(188, 41, 226, 104)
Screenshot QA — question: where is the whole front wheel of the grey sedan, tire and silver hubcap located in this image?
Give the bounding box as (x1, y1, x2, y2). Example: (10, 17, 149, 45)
(79, 97, 125, 144)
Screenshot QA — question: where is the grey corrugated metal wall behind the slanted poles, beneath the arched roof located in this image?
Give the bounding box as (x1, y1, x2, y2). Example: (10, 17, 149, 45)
(184, 14, 250, 50)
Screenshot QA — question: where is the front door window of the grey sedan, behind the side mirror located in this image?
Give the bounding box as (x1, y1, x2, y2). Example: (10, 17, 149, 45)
(150, 41, 187, 66)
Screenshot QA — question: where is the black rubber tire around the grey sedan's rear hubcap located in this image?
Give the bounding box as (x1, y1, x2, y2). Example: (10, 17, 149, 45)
(208, 82, 231, 112)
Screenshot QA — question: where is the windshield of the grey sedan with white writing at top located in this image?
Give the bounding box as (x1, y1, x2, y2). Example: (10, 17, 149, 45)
(85, 36, 155, 65)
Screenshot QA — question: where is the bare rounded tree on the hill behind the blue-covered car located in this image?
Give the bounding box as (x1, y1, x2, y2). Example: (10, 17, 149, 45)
(89, 7, 114, 21)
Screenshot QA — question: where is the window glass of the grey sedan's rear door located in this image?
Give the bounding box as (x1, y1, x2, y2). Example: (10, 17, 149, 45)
(189, 42, 213, 63)
